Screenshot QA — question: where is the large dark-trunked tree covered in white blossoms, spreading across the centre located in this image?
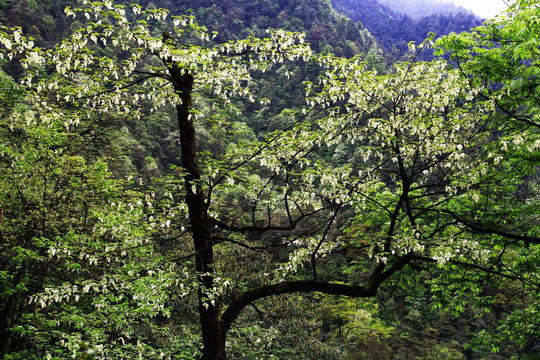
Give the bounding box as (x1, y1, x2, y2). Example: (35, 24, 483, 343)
(0, 2, 538, 360)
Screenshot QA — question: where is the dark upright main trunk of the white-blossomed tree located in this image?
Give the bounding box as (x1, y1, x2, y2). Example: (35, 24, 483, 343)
(169, 69, 226, 360)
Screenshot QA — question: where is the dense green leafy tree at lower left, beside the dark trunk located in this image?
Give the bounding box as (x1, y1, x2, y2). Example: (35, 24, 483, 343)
(0, 69, 188, 359)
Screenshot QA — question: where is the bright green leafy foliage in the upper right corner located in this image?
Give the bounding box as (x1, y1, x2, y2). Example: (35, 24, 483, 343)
(437, 1, 540, 127)
